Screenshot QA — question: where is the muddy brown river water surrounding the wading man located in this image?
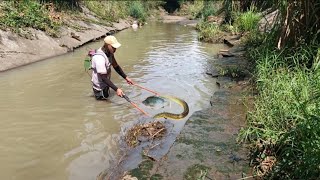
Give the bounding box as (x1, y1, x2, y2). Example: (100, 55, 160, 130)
(0, 23, 222, 180)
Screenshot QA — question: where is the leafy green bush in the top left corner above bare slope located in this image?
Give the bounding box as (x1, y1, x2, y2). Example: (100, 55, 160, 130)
(0, 0, 60, 35)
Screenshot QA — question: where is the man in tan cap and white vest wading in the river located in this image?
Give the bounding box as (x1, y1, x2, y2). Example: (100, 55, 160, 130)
(91, 36, 133, 100)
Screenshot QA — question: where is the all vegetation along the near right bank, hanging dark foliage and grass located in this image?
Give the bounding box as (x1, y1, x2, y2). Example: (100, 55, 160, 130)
(235, 1, 320, 179)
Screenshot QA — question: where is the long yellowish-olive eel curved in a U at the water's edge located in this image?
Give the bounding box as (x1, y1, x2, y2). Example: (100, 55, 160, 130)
(153, 95, 189, 120)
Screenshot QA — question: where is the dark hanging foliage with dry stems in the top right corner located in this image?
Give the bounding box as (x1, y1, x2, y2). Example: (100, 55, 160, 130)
(273, 0, 320, 49)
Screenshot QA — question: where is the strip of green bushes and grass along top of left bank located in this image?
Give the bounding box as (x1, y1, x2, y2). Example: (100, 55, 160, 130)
(0, 0, 164, 37)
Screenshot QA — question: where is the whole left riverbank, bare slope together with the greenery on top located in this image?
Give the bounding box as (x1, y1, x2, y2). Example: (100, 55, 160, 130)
(0, 0, 165, 72)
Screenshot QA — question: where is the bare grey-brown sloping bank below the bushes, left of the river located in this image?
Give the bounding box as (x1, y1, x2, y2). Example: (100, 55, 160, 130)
(0, 11, 131, 72)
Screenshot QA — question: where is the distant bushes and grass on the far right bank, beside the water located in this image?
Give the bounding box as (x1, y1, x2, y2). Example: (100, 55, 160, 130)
(184, 0, 261, 42)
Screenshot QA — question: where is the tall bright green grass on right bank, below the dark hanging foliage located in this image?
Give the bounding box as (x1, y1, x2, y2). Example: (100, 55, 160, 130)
(239, 46, 320, 179)
